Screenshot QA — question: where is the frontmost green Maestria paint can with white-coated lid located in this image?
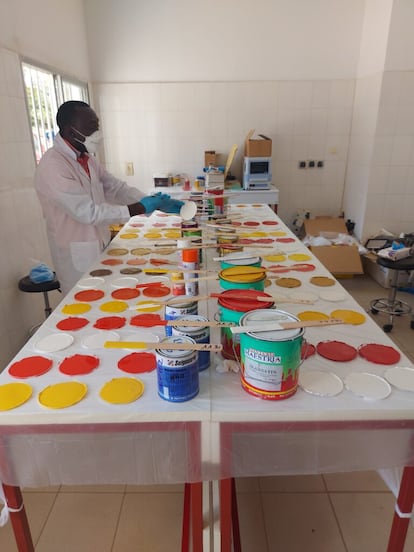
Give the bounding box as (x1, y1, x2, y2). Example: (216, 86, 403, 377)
(240, 309, 304, 400)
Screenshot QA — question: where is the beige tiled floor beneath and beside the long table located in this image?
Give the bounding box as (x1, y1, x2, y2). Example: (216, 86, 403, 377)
(0, 277, 414, 552)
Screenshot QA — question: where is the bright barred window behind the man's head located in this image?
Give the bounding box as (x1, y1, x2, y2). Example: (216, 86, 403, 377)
(22, 62, 89, 163)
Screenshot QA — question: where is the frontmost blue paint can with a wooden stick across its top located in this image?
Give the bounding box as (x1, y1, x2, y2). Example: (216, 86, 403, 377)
(155, 336, 200, 402)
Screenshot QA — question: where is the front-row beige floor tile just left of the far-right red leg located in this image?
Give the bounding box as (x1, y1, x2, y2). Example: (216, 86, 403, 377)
(330, 493, 414, 552)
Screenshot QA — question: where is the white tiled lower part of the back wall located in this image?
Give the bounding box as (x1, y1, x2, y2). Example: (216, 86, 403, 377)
(93, 80, 354, 223)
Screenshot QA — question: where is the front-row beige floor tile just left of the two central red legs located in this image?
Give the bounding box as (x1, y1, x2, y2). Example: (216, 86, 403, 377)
(112, 493, 183, 552)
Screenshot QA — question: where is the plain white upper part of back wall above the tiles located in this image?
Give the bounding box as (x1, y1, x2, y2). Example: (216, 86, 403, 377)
(85, 0, 365, 82)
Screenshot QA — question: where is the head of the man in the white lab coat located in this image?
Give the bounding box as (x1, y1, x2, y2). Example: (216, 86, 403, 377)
(56, 100, 99, 151)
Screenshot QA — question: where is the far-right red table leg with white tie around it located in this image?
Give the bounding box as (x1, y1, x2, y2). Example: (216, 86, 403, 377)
(387, 467, 414, 552)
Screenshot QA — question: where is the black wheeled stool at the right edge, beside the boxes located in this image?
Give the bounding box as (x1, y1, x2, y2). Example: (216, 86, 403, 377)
(370, 257, 414, 333)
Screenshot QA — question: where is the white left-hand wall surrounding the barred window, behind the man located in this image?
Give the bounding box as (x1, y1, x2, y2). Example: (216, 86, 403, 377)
(0, 0, 89, 370)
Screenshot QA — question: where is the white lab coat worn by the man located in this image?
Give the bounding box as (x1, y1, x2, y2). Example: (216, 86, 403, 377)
(35, 134, 144, 294)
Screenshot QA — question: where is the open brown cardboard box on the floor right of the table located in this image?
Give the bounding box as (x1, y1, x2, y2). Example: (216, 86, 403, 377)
(304, 217, 363, 278)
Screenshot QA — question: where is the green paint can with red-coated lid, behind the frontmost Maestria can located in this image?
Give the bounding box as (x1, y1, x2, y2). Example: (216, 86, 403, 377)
(218, 289, 274, 360)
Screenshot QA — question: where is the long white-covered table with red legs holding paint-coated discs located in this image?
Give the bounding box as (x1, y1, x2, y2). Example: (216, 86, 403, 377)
(0, 204, 414, 552)
